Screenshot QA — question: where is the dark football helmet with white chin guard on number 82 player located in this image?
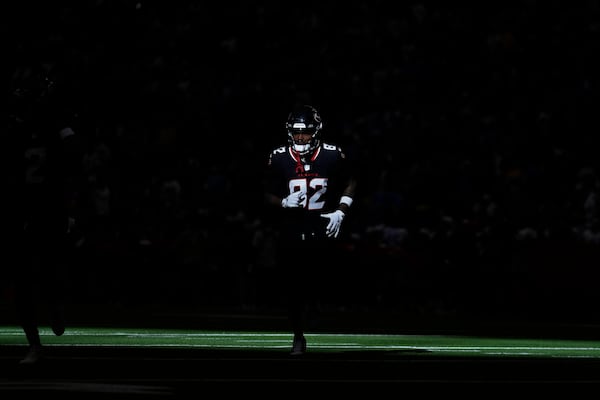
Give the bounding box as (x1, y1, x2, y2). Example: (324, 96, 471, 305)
(285, 104, 323, 155)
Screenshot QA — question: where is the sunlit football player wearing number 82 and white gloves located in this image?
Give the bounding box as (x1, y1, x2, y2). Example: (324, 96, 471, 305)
(265, 105, 357, 355)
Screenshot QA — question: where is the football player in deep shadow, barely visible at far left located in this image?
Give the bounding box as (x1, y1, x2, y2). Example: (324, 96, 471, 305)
(6, 68, 83, 364)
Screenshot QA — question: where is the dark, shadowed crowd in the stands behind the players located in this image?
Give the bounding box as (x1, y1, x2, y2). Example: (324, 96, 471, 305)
(0, 0, 600, 320)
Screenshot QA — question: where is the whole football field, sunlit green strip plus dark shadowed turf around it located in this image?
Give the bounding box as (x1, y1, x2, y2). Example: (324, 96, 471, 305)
(0, 307, 600, 399)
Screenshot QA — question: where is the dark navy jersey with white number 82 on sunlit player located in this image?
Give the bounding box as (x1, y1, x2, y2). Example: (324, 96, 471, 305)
(266, 143, 352, 237)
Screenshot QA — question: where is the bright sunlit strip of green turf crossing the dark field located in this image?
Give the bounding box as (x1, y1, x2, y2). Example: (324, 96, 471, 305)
(0, 326, 600, 359)
